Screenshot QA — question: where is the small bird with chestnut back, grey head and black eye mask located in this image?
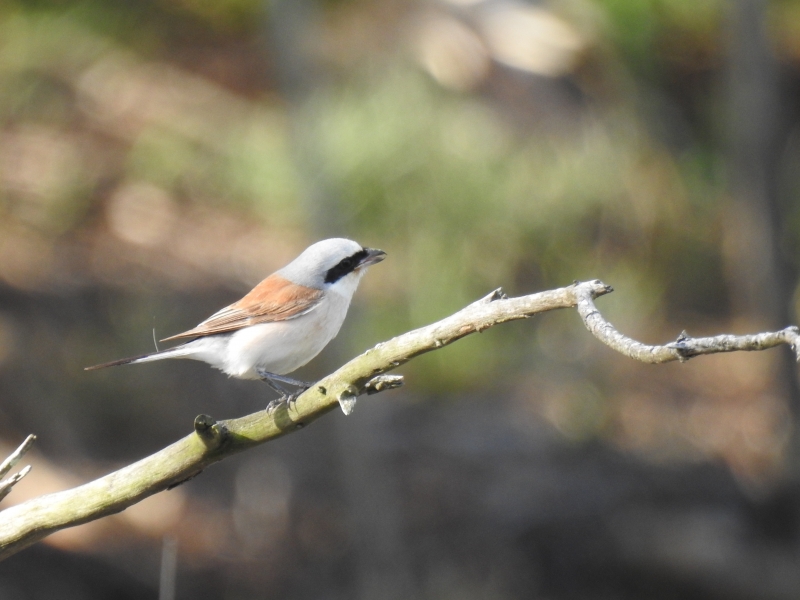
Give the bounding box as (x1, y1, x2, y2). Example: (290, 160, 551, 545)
(85, 238, 386, 402)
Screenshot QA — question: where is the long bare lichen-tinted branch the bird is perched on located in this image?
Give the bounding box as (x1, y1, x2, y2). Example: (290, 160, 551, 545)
(0, 280, 798, 559)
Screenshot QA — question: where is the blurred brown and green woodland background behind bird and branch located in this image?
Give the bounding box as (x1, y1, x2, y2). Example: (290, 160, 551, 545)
(0, 0, 800, 600)
